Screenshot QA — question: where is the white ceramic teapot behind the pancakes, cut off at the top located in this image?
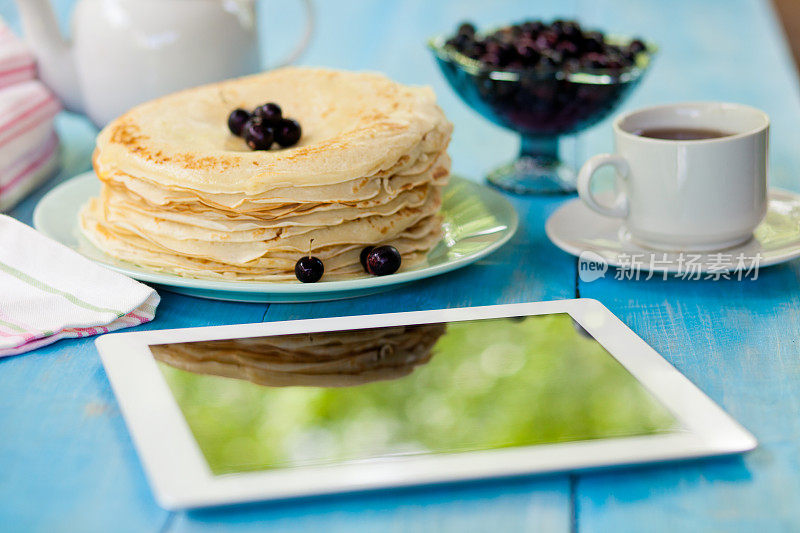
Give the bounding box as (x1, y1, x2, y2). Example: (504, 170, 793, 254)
(17, 0, 313, 126)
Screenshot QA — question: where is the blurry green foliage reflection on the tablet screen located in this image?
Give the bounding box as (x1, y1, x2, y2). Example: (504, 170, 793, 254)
(156, 314, 677, 474)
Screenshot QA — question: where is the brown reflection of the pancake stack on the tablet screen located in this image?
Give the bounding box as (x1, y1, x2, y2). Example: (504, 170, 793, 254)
(151, 324, 445, 387)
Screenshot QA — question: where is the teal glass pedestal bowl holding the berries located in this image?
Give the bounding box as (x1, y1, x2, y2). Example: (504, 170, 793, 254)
(428, 36, 655, 194)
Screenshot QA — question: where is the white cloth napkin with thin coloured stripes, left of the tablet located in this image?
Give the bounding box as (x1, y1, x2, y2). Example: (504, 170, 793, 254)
(0, 215, 160, 357)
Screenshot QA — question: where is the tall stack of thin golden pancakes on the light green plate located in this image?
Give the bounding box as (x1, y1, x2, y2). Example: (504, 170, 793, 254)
(81, 68, 452, 281)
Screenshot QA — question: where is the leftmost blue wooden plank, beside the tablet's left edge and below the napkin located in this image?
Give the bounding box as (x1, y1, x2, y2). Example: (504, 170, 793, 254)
(0, 113, 267, 532)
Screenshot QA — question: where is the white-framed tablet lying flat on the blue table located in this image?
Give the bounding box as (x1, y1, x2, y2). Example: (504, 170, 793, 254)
(97, 299, 756, 509)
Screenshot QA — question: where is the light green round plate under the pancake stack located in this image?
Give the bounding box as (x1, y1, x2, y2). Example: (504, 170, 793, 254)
(33, 172, 519, 303)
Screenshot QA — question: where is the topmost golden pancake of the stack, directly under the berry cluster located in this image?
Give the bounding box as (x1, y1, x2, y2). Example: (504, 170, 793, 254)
(96, 67, 451, 194)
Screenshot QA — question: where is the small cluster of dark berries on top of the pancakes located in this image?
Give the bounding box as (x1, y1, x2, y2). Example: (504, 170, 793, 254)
(228, 102, 302, 150)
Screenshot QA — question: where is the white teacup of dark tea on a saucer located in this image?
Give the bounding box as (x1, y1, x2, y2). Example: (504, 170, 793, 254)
(578, 102, 769, 251)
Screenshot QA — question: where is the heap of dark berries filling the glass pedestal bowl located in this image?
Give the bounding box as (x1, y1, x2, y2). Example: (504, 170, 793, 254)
(446, 20, 647, 72)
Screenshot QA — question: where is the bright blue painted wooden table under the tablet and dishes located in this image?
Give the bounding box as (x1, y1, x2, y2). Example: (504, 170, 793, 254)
(0, 0, 800, 532)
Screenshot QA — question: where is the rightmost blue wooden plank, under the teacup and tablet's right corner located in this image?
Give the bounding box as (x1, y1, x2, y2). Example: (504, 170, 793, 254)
(576, 1, 800, 532)
